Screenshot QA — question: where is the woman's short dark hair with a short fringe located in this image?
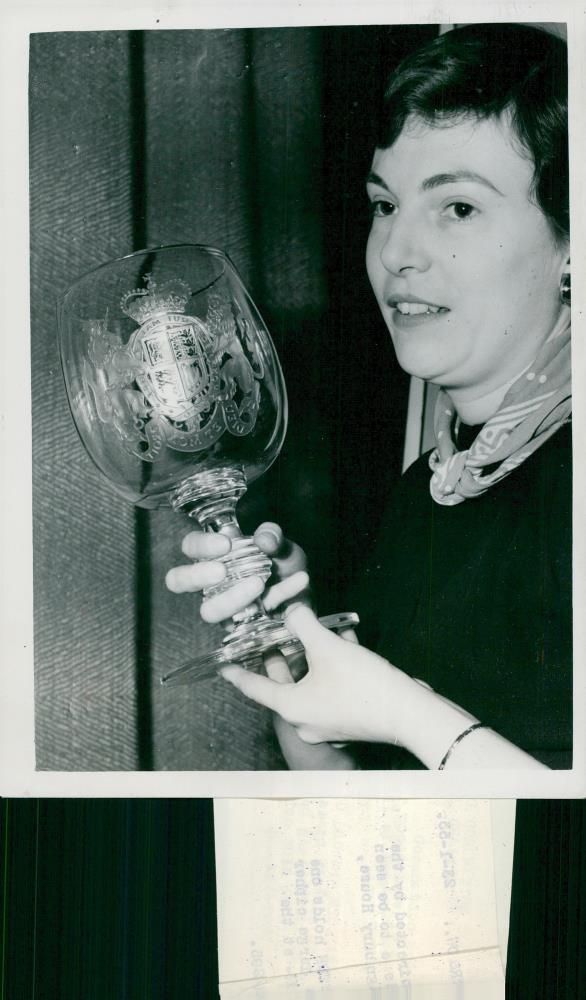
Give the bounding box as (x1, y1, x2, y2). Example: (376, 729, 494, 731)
(377, 24, 570, 241)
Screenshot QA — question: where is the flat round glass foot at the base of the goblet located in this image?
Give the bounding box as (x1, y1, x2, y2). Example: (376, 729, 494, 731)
(161, 612, 359, 687)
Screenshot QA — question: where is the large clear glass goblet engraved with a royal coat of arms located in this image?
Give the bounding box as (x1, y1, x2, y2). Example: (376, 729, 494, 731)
(59, 244, 358, 686)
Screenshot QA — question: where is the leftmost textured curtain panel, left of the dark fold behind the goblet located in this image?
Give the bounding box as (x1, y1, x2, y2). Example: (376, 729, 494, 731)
(30, 32, 137, 770)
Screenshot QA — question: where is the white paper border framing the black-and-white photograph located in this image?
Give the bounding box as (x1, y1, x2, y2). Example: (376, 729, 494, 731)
(0, 0, 586, 798)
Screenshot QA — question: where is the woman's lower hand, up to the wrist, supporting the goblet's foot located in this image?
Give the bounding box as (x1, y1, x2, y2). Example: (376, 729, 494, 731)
(220, 606, 421, 745)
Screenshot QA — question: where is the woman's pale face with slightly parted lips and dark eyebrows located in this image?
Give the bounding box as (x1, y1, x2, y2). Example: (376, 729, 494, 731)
(366, 110, 568, 405)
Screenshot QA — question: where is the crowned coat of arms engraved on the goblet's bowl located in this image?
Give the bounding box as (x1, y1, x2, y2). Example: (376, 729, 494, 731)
(83, 275, 264, 461)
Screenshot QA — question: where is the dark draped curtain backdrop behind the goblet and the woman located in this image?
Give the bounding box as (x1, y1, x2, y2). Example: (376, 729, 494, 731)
(30, 25, 436, 770)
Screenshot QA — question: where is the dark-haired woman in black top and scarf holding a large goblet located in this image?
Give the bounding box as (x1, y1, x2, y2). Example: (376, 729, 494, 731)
(167, 25, 571, 768)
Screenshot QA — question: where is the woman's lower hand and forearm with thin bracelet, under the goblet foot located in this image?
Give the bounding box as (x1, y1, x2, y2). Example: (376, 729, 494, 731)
(220, 606, 543, 769)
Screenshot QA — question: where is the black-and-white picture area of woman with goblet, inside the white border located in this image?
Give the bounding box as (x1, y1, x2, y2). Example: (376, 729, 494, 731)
(21, 11, 576, 794)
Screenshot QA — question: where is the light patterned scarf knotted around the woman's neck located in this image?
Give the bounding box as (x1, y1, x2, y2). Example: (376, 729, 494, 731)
(429, 313, 572, 507)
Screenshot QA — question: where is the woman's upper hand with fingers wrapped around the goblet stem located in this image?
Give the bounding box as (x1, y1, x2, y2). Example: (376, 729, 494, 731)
(165, 521, 310, 623)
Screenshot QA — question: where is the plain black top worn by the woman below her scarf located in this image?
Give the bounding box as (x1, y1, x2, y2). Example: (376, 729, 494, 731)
(358, 424, 572, 769)
